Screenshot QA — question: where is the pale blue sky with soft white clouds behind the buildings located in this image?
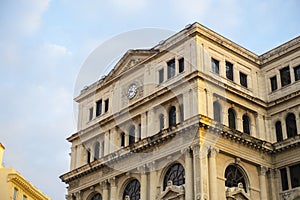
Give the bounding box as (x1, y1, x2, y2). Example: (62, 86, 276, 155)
(0, 0, 300, 200)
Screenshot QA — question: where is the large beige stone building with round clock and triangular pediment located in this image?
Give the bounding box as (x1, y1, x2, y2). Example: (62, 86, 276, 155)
(60, 23, 300, 200)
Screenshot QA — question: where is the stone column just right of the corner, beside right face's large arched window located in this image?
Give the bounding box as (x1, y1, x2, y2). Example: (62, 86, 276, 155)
(208, 147, 219, 200)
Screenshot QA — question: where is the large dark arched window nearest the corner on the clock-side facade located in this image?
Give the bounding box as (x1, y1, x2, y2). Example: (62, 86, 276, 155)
(163, 163, 185, 190)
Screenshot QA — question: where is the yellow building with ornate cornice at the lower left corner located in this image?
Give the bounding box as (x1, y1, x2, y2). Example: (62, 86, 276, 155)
(0, 143, 51, 200)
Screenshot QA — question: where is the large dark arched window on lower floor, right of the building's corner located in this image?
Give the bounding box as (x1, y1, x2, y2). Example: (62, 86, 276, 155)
(225, 165, 247, 192)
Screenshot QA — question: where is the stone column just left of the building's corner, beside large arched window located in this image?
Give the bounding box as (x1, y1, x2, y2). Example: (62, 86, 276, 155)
(184, 148, 194, 199)
